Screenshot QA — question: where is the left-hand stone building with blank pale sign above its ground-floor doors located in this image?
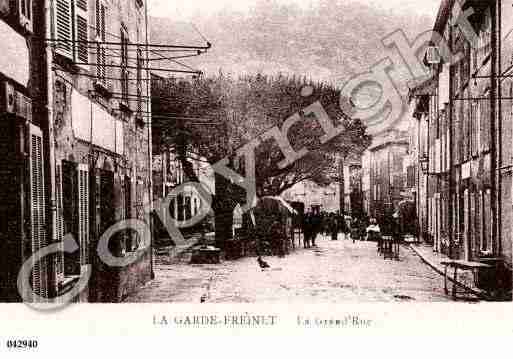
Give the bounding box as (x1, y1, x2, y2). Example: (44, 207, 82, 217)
(49, 0, 153, 302)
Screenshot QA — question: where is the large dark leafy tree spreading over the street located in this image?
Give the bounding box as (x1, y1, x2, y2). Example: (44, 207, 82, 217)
(152, 73, 371, 248)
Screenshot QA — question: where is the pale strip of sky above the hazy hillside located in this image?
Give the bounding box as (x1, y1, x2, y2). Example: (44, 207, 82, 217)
(148, 0, 440, 20)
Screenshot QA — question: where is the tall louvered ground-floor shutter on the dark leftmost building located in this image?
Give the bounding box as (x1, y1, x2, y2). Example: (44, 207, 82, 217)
(30, 125, 48, 297)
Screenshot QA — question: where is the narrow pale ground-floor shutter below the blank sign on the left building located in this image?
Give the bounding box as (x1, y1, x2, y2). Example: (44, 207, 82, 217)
(78, 164, 89, 265)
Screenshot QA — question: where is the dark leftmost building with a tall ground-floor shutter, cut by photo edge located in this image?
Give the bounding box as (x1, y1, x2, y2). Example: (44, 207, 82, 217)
(0, 0, 47, 302)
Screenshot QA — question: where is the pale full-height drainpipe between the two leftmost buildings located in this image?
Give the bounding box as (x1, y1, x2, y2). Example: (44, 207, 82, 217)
(44, 0, 58, 296)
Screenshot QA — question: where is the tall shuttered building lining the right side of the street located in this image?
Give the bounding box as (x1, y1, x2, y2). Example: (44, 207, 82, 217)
(410, 0, 513, 287)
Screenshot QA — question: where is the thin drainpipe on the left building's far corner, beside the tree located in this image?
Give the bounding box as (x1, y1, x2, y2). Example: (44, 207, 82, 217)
(144, 0, 155, 279)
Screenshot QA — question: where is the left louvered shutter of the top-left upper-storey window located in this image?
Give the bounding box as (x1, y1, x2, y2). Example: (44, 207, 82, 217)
(54, 0, 73, 60)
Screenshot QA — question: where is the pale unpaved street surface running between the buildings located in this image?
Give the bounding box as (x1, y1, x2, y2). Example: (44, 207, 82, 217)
(126, 238, 449, 303)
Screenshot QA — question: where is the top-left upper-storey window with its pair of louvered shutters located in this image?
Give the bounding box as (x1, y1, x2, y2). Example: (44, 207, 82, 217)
(54, 0, 90, 66)
